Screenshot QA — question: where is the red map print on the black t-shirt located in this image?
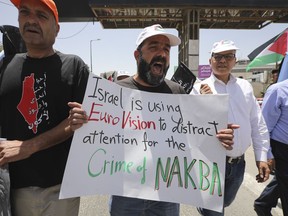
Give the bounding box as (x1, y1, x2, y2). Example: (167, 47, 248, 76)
(17, 74, 38, 133)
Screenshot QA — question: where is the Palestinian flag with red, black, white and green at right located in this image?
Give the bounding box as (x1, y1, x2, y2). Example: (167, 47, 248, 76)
(246, 28, 288, 71)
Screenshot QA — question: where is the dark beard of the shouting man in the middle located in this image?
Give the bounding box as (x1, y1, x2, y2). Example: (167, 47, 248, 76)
(138, 55, 169, 86)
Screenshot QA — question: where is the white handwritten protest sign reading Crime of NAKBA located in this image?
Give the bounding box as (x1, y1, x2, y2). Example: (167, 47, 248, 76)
(60, 75, 228, 211)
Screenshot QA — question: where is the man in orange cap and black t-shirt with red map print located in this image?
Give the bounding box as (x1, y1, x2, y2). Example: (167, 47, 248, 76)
(0, 0, 89, 216)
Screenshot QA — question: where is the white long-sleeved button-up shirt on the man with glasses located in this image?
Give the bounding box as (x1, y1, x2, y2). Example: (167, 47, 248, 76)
(193, 74, 270, 161)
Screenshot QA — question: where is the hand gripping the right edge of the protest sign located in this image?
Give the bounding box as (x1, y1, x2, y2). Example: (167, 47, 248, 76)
(216, 124, 240, 150)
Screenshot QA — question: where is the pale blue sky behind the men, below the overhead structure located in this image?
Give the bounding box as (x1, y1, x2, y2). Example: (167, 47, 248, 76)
(0, 0, 288, 78)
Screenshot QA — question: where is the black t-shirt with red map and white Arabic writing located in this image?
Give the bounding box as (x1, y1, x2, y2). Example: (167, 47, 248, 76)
(0, 52, 89, 188)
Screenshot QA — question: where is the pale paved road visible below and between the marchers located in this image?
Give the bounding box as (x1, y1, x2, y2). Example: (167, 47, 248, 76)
(79, 148, 283, 216)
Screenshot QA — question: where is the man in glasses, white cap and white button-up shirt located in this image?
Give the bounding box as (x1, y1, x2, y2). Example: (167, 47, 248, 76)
(198, 40, 270, 216)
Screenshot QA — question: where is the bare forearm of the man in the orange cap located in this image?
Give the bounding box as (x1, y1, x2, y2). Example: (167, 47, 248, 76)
(0, 119, 73, 166)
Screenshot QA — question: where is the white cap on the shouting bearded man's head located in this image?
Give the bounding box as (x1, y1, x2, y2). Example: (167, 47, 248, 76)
(136, 24, 181, 47)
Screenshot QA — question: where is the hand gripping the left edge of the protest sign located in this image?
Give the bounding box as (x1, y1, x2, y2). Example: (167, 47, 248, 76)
(68, 102, 88, 131)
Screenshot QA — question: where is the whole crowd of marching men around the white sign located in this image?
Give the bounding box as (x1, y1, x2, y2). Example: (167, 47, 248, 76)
(0, 0, 288, 216)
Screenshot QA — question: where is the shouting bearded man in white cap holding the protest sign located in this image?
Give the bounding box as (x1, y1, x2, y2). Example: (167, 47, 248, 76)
(69, 24, 238, 216)
